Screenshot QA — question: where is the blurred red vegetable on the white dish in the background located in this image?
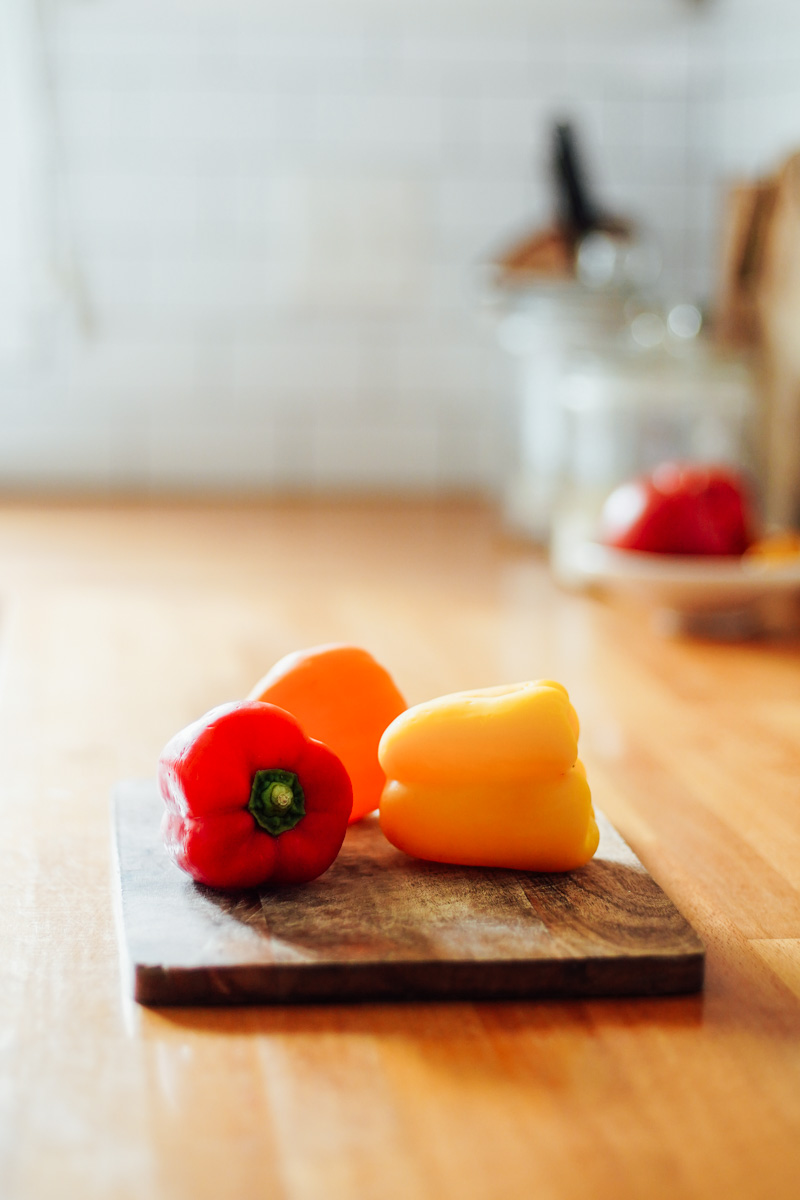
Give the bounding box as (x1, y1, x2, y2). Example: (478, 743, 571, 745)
(601, 462, 753, 554)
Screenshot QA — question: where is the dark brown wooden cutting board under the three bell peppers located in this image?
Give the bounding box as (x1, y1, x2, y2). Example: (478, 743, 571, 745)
(114, 781, 704, 1004)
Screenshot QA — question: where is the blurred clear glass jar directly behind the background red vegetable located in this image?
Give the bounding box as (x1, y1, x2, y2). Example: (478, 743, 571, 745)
(551, 333, 757, 587)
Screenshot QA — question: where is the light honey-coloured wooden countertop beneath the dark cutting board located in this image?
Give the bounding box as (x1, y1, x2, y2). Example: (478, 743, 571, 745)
(0, 503, 800, 1200)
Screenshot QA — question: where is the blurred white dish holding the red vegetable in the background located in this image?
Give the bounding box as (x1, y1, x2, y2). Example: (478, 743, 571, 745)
(569, 541, 800, 636)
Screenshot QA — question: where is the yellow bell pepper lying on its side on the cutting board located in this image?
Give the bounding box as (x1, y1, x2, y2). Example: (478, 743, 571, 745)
(378, 679, 599, 871)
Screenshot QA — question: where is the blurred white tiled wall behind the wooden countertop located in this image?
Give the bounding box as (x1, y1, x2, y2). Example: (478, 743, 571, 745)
(0, 0, 800, 490)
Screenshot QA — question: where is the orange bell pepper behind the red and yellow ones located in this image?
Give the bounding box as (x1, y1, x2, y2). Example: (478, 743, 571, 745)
(248, 643, 405, 822)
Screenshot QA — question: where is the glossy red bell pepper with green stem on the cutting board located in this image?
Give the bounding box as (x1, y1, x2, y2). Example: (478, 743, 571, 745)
(158, 701, 353, 888)
